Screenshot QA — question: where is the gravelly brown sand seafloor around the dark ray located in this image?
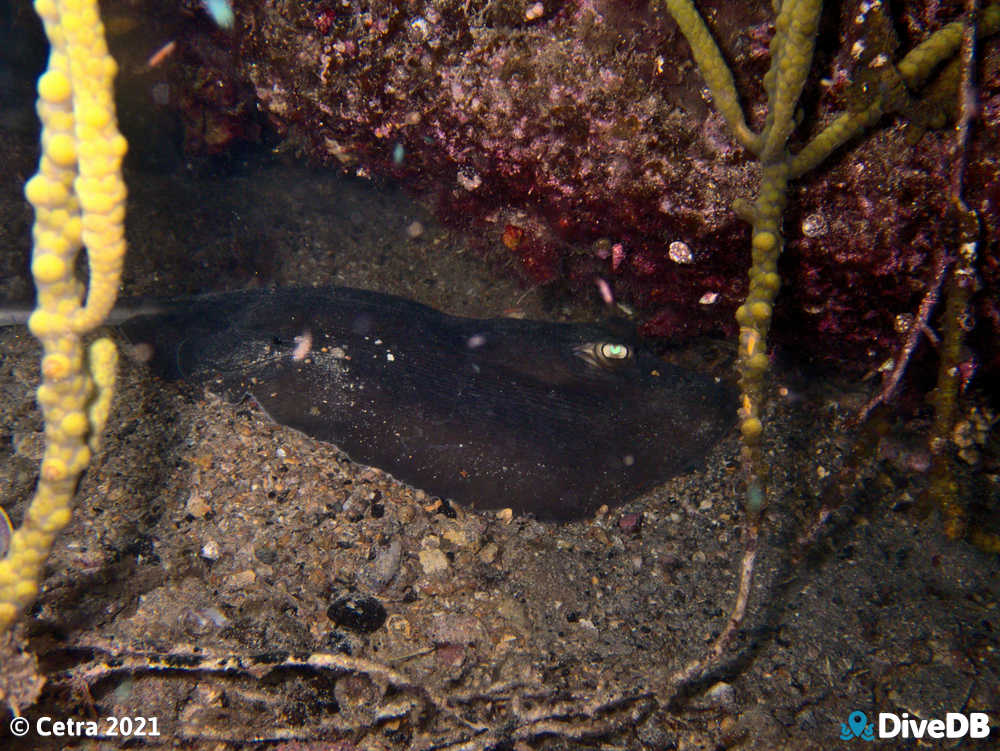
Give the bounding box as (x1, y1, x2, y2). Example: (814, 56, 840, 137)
(0, 23, 1000, 751)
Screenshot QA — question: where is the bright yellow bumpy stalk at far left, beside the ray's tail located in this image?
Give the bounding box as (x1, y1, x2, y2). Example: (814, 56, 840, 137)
(0, 0, 127, 631)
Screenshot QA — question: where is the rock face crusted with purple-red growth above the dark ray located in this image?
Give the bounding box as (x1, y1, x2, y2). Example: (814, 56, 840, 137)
(170, 0, 1000, 376)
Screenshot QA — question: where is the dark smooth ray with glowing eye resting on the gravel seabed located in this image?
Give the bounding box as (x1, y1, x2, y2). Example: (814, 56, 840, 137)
(121, 287, 736, 519)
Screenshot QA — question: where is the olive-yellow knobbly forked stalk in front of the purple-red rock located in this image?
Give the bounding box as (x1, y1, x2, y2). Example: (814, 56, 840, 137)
(663, 0, 1000, 515)
